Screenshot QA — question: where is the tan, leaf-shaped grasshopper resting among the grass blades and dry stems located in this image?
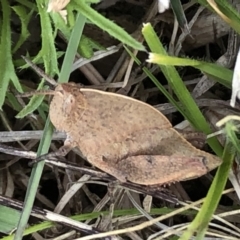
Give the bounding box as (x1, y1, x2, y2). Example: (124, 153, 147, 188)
(29, 83, 221, 185)
